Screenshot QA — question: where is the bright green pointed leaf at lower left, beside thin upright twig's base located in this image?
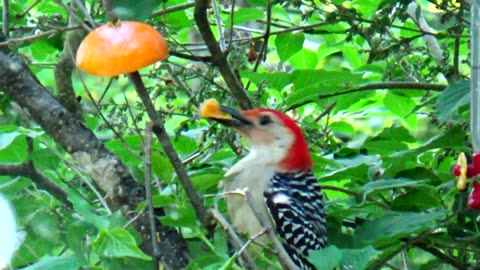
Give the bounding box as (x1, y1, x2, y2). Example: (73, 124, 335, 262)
(92, 227, 151, 260)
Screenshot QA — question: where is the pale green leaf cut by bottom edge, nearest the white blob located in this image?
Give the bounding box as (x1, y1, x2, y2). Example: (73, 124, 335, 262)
(22, 253, 86, 270)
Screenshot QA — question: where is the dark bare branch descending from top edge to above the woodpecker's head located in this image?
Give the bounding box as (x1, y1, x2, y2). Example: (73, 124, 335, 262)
(194, 0, 252, 109)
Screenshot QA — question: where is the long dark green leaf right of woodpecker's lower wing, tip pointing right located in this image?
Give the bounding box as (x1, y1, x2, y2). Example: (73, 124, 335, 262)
(355, 209, 448, 244)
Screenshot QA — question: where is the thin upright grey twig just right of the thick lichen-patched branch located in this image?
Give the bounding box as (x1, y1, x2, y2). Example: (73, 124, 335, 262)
(143, 122, 160, 269)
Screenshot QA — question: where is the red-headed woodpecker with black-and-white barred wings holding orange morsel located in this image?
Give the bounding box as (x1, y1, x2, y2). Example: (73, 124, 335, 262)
(200, 100, 327, 269)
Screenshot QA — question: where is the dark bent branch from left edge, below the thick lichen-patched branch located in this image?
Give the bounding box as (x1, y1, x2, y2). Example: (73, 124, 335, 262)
(0, 162, 72, 207)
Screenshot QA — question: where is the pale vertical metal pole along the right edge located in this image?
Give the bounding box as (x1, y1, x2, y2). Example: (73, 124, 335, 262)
(470, 0, 480, 152)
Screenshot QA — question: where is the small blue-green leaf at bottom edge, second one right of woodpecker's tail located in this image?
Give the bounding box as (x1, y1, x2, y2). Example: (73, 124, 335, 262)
(340, 246, 381, 270)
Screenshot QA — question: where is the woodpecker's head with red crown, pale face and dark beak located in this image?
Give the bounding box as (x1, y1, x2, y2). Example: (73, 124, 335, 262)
(202, 102, 312, 172)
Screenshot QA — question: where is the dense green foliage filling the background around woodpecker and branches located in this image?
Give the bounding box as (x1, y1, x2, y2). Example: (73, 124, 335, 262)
(0, 0, 474, 269)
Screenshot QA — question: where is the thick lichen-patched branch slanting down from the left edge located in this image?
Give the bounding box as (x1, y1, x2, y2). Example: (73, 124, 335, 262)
(0, 53, 189, 269)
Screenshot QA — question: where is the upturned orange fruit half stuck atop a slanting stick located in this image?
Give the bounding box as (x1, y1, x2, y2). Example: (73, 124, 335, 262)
(76, 21, 168, 76)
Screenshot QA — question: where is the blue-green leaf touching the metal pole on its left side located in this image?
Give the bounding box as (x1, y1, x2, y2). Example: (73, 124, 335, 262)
(437, 80, 470, 122)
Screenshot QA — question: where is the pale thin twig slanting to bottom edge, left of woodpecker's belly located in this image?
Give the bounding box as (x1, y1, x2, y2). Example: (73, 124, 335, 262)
(210, 208, 258, 269)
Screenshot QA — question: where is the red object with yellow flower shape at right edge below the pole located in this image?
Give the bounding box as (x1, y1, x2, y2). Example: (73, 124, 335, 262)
(453, 153, 480, 210)
